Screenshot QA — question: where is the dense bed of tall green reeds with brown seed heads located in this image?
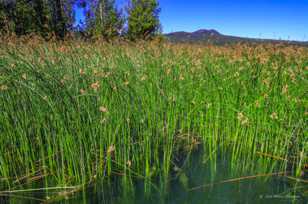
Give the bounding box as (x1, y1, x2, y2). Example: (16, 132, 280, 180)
(0, 41, 308, 201)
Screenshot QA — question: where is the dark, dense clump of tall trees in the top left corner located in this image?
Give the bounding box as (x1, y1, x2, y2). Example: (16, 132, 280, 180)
(0, 0, 76, 39)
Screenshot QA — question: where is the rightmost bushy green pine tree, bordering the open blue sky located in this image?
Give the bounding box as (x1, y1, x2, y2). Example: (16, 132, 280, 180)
(127, 0, 160, 40)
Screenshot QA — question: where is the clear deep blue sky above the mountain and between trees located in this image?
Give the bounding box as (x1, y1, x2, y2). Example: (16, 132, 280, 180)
(76, 0, 308, 41)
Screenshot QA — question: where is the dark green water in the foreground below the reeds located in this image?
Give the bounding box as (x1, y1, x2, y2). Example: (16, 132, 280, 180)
(0, 151, 308, 204)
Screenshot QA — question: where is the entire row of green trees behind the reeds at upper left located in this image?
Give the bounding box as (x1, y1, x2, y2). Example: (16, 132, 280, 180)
(0, 0, 161, 40)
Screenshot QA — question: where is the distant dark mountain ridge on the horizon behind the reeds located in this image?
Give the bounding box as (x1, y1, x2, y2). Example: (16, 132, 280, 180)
(165, 29, 308, 46)
